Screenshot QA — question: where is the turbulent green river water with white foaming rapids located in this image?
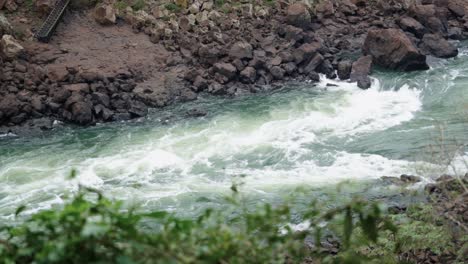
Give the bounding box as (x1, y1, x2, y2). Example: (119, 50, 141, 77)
(0, 45, 468, 220)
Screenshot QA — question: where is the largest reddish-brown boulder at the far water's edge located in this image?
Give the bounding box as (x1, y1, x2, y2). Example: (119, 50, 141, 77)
(363, 29, 429, 71)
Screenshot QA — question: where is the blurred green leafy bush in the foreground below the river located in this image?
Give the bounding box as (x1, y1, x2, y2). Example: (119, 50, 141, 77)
(0, 188, 396, 263)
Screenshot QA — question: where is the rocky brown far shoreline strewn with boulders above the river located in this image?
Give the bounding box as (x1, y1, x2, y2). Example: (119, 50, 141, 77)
(0, 0, 468, 134)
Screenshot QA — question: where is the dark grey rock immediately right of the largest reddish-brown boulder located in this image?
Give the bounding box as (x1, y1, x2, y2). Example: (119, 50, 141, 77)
(420, 34, 458, 58)
